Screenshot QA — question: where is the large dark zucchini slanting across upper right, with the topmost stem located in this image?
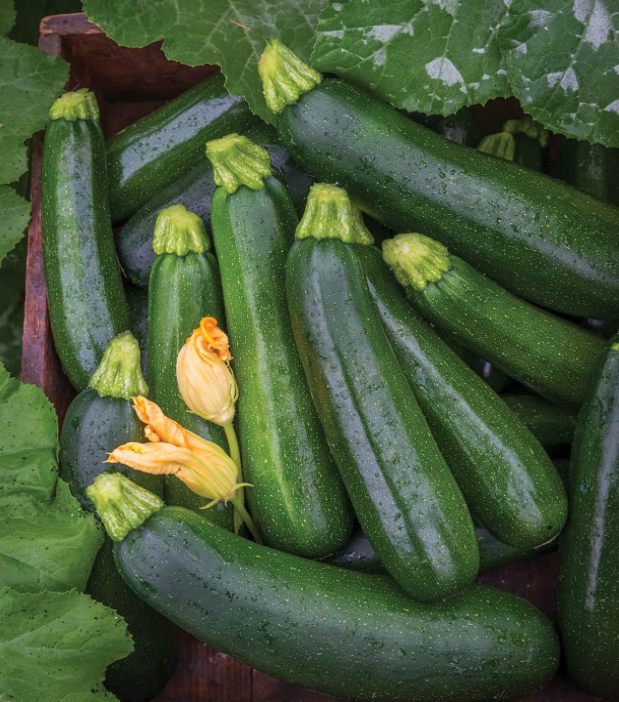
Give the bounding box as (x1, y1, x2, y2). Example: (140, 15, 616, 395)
(259, 41, 619, 319)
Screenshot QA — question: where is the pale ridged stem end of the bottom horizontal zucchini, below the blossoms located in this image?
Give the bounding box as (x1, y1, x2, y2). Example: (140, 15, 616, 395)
(86, 473, 165, 541)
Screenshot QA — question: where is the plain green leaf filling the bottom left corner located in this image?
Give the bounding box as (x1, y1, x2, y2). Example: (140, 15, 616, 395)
(0, 588, 133, 702)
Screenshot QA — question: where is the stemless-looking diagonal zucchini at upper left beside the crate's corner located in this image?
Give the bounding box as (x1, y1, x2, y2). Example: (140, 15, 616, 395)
(105, 74, 258, 222)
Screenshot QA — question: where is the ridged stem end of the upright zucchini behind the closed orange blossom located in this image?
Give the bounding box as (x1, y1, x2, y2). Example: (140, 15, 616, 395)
(153, 204, 210, 256)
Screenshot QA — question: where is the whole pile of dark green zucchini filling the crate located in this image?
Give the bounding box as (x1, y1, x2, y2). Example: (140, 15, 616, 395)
(42, 41, 619, 702)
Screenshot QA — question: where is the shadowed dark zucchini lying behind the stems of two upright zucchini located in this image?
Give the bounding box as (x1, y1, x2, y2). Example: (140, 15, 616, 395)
(116, 123, 311, 287)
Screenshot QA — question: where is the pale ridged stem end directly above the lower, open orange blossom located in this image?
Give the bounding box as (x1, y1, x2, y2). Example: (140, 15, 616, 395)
(88, 331, 148, 400)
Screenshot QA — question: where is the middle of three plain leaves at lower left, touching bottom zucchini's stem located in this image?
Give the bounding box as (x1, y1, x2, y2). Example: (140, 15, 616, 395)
(0, 480, 103, 593)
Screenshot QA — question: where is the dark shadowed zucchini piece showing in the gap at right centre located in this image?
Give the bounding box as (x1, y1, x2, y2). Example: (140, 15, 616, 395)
(501, 395, 577, 452)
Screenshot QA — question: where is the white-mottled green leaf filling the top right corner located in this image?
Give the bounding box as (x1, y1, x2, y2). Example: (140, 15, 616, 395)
(499, 0, 619, 146)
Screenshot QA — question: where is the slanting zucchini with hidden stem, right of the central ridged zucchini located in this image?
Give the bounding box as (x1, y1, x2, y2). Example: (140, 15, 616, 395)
(356, 246, 567, 548)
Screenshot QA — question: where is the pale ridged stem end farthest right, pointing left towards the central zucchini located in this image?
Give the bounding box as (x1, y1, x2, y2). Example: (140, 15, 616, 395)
(383, 234, 451, 290)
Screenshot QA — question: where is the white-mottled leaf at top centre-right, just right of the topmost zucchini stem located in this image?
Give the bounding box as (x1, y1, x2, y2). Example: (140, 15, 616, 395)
(313, 0, 509, 115)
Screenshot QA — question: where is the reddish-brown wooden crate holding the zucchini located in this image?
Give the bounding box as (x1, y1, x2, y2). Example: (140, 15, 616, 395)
(22, 14, 601, 702)
